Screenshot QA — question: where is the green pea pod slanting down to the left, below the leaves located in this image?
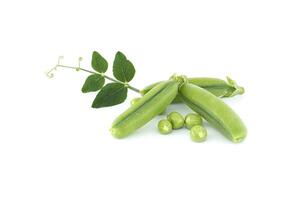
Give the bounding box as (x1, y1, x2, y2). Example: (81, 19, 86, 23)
(111, 80, 180, 138)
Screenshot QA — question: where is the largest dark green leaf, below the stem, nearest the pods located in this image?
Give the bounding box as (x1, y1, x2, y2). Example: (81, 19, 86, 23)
(92, 83, 128, 108)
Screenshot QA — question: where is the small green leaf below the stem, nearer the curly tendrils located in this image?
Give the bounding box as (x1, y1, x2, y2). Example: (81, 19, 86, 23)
(82, 74, 105, 93)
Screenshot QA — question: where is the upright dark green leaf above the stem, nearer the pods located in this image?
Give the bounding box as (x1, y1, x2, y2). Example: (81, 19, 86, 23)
(113, 51, 135, 82)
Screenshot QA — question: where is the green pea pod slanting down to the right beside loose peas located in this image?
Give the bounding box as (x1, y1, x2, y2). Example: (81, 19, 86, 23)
(179, 83, 247, 143)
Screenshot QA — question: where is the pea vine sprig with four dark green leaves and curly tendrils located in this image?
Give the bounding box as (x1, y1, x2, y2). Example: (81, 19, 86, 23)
(47, 51, 140, 108)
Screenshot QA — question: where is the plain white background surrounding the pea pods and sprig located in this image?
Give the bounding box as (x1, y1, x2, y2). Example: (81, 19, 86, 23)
(0, 0, 301, 200)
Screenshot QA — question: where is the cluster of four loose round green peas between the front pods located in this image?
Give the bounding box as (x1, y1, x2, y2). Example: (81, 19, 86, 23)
(158, 112, 207, 142)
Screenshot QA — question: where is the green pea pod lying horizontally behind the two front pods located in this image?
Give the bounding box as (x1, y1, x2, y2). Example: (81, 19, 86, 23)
(140, 77, 244, 103)
